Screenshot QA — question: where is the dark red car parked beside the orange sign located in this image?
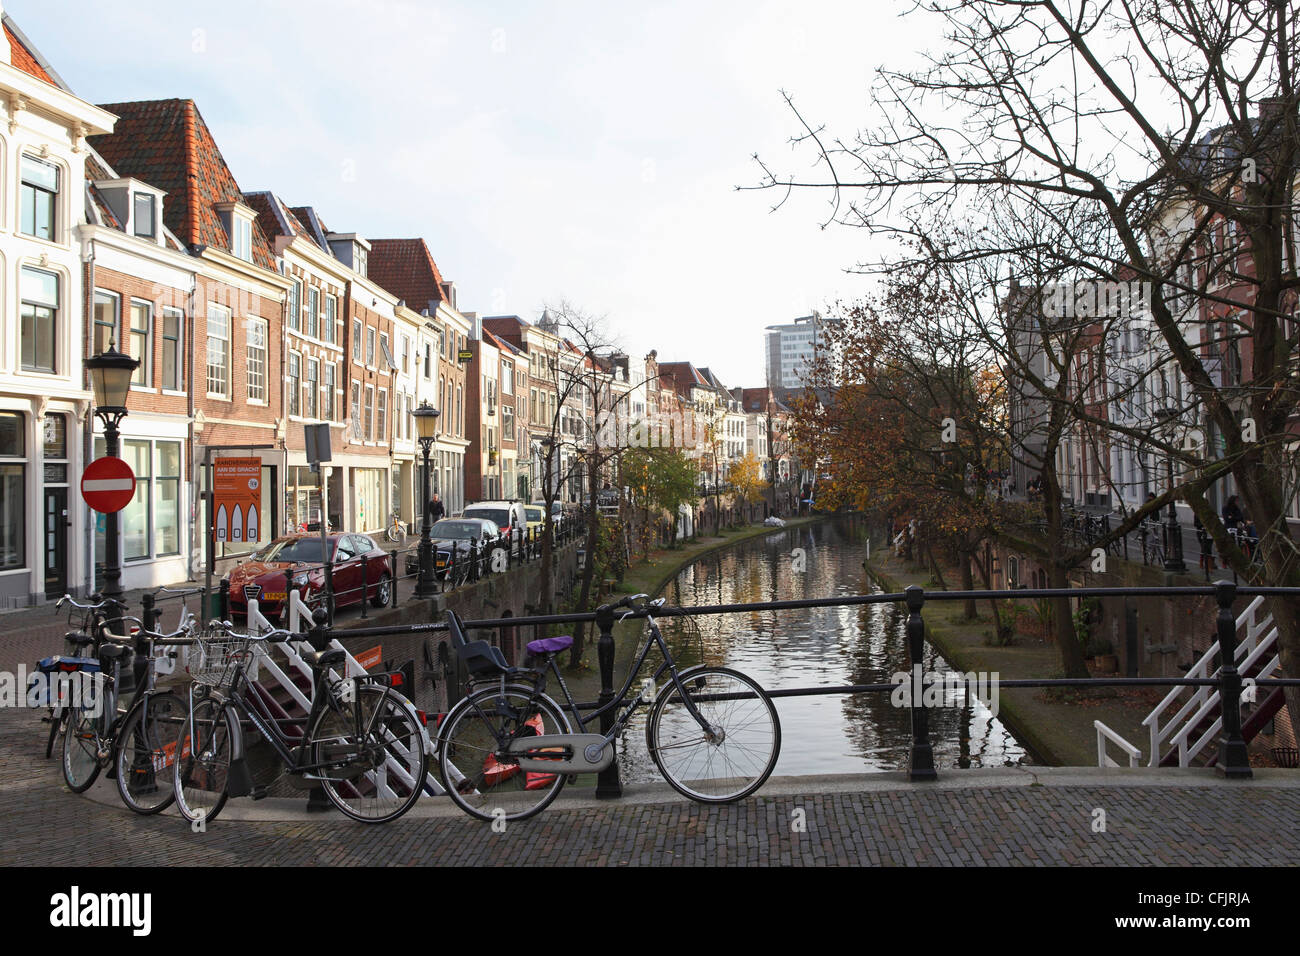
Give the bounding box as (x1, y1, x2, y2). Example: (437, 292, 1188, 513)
(226, 535, 393, 620)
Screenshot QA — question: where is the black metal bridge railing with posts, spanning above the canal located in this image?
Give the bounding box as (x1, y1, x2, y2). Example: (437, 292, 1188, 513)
(183, 581, 1300, 796)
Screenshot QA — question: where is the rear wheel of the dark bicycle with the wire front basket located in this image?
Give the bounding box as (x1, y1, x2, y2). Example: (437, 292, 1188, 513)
(307, 684, 429, 823)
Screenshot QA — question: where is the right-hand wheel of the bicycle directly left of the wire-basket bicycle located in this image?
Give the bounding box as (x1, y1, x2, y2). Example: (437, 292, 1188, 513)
(117, 693, 186, 814)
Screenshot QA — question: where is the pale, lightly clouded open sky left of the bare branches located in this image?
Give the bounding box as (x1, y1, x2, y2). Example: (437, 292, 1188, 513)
(4, 0, 924, 386)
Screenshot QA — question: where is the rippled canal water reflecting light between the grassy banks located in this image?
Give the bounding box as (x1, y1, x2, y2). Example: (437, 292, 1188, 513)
(621, 518, 1030, 782)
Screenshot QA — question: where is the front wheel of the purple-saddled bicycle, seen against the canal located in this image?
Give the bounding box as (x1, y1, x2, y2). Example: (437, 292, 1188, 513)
(646, 667, 781, 804)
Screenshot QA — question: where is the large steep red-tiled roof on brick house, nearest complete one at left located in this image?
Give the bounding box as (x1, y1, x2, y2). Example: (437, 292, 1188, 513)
(88, 99, 276, 271)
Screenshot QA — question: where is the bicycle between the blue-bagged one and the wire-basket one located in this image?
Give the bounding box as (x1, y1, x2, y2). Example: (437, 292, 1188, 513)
(62, 613, 195, 814)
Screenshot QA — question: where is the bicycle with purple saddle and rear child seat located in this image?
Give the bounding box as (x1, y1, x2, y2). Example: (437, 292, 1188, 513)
(438, 594, 781, 821)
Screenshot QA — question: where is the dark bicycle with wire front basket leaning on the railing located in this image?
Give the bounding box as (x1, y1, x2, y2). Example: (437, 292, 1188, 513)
(173, 622, 428, 825)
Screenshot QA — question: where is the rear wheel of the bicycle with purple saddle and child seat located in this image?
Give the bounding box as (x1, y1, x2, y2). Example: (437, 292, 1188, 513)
(438, 684, 572, 821)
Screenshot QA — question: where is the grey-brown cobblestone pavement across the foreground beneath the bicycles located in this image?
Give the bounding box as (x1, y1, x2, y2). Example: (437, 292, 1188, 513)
(0, 709, 1300, 866)
